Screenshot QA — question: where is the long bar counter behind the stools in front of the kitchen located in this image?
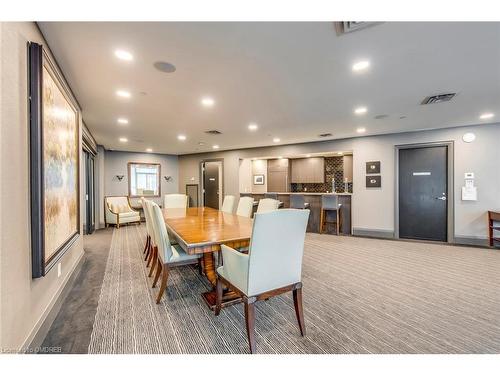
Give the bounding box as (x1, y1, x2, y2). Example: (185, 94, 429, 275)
(240, 192, 352, 235)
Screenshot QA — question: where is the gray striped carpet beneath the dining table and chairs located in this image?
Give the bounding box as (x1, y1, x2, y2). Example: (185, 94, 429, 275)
(89, 225, 500, 354)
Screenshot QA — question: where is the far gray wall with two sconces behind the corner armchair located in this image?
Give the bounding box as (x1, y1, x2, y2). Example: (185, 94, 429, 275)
(98, 147, 179, 224)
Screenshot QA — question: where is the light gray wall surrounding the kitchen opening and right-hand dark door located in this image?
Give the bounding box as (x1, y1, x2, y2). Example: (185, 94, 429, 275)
(179, 123, 500, 241)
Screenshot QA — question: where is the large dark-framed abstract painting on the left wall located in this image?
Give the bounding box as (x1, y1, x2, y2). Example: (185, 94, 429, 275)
(28, 43, 80, 278)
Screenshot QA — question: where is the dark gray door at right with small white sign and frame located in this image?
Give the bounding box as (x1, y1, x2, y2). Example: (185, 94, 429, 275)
(399, 146, 448, 241)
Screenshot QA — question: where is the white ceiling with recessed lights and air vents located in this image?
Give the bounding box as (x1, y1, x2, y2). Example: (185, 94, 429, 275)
(39, 22, 500, 154)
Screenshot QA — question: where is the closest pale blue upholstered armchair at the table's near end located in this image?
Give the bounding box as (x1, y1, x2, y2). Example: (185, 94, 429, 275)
(215, 209, 309, 353)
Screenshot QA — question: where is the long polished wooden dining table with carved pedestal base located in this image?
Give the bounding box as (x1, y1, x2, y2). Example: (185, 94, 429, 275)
(162, 207, 253, 310)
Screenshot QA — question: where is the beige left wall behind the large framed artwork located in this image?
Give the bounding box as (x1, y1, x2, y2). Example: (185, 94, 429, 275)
(0, 22, 83, 351)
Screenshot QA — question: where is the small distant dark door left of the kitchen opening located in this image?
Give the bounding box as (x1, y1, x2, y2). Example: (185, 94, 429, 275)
(201, 160, 223, 210)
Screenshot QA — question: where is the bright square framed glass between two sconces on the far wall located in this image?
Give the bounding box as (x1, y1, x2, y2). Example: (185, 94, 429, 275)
(128, 163, 160, 197)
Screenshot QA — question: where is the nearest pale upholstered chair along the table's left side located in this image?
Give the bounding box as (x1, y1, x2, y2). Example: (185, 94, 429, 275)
(148, 202, 201, 303)
